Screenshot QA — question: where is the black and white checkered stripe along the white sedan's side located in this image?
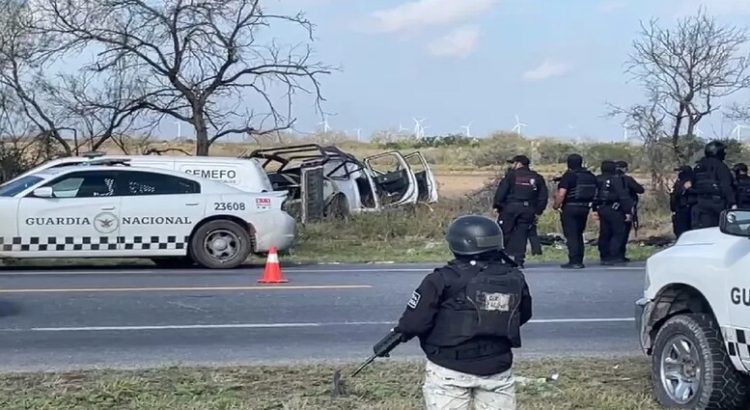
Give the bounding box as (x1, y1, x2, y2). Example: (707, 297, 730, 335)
(0, 235, 189, 252)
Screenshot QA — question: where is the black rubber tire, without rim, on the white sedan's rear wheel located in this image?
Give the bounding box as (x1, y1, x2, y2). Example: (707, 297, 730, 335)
(190, 219, 252, 269)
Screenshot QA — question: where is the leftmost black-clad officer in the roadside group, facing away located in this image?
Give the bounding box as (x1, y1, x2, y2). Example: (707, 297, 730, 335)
(494, 155, 549, 268)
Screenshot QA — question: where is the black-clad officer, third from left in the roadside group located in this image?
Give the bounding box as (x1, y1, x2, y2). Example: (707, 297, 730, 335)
(594, 161, 633, 265)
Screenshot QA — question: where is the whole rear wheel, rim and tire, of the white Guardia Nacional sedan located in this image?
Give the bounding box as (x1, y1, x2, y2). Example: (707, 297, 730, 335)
(190, 220, 252, 269)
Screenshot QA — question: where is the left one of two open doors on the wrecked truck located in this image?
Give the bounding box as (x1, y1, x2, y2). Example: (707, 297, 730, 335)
(364, 151, 419, 206)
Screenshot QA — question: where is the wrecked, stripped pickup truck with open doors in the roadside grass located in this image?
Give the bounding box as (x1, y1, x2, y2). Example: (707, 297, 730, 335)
(243, 144, 438, 221)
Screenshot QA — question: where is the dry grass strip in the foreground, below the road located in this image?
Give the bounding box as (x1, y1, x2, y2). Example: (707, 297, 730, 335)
(0, 358, 660, 410)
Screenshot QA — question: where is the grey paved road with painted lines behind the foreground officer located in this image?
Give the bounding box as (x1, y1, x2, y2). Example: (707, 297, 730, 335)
(0, 265, 643, 371)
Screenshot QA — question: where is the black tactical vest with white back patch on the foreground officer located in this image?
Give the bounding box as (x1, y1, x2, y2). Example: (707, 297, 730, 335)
(425, 262, 525, 347)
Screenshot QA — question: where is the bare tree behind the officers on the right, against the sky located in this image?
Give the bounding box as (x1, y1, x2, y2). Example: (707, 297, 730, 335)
(621, 8, 750, 161)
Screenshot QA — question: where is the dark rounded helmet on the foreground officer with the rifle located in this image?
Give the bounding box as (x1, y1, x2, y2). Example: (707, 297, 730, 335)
(445, 215, 503, 255)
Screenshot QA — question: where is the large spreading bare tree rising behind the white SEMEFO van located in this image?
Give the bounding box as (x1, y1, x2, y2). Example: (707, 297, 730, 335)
(38, 0, 331, 155)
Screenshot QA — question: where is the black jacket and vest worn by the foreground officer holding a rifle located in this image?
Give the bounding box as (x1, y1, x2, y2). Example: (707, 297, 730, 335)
(394, 257, 531, 376)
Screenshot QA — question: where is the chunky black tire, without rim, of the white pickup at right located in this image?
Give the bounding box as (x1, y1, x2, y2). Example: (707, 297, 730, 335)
(651, 313, 748, 409)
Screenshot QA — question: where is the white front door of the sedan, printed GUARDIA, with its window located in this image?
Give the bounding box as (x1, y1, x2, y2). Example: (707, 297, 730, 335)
(13, 170, 121, 257)
